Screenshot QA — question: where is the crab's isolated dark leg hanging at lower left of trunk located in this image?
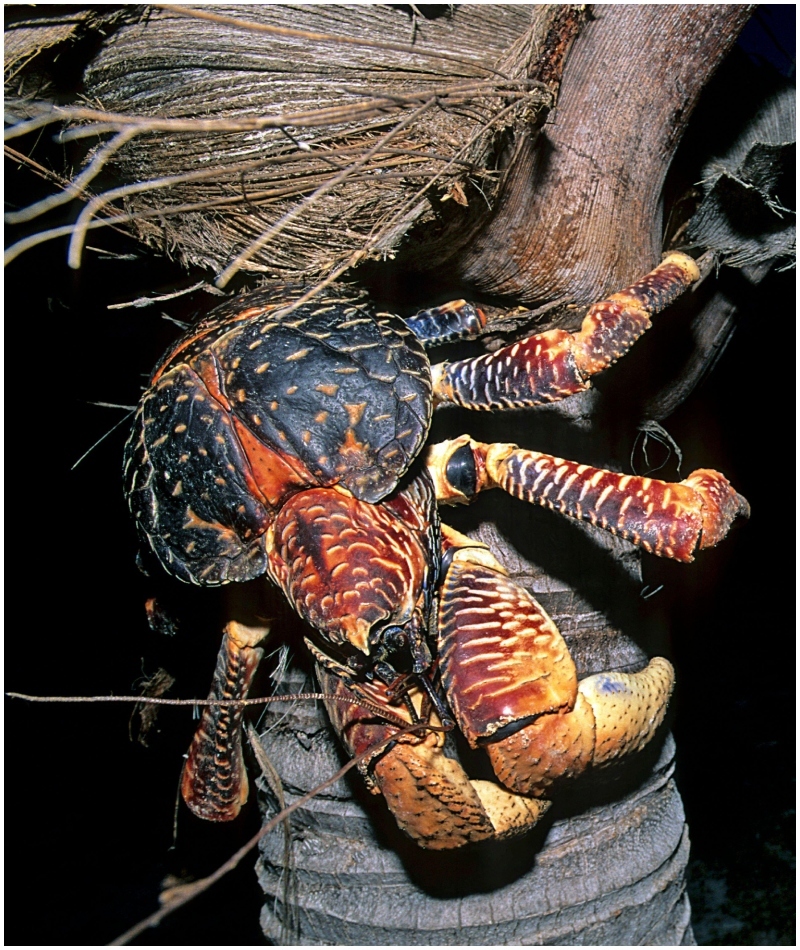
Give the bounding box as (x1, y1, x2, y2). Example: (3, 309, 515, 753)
(181, 621, 269, 821)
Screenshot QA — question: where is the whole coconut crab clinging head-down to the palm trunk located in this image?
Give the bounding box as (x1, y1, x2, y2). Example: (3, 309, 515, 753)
(125, 254, 748, 849)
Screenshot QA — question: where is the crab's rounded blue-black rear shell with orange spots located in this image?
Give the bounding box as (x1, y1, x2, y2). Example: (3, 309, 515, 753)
(124, 288, 432, 585)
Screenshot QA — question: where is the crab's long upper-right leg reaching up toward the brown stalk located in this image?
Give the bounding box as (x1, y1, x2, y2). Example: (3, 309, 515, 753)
(431, 253, 700, 410)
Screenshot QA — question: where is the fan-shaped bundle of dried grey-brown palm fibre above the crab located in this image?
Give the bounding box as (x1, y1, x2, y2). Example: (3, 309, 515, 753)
(7, 5, 584, 280)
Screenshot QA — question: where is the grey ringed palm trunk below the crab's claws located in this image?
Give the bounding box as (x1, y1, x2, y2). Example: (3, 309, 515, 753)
(258, 683, 694, 946)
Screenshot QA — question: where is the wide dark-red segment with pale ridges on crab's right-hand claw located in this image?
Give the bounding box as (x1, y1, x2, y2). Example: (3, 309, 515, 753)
(438, 561, 577, 746)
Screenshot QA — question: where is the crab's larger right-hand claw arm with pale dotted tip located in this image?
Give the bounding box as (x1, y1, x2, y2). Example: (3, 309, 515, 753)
(439, 529, 674, 796)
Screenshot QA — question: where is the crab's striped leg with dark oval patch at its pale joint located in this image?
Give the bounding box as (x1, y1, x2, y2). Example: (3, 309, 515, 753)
(427, 436, 750, 562)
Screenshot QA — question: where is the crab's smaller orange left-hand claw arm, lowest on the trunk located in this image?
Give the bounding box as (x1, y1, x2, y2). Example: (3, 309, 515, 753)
(317, 663, 549, 850)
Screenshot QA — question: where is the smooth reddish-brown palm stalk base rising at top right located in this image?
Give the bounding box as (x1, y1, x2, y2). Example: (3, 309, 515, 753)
(452, 4, 751, 304)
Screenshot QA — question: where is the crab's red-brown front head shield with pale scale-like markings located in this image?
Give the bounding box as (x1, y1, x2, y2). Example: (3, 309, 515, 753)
(269, 488, 428, 653)
